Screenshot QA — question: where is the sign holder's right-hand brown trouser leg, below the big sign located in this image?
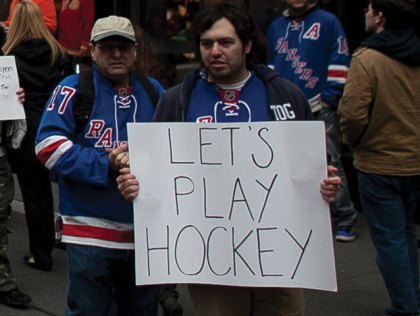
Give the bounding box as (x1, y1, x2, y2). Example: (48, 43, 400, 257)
(252, 288, 305, 316)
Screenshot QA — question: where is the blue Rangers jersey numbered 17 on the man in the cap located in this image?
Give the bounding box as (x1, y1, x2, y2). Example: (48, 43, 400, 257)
(36, 69, 163, 249)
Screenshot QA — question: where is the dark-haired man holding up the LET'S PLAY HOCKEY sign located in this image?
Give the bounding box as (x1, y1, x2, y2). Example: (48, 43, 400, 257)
(115, 2, 340, 316)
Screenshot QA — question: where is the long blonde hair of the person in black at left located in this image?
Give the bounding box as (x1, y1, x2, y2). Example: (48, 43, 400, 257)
(2, 1, 66, 65)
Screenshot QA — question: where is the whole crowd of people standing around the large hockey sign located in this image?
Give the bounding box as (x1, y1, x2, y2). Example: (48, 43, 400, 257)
(0, 0, 420, 316)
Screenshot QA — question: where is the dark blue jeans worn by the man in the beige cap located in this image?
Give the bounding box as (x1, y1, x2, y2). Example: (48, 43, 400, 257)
(66, 244, 160, 316)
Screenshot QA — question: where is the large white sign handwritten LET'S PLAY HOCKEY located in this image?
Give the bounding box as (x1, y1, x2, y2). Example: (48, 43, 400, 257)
(128, 122, 336, 291)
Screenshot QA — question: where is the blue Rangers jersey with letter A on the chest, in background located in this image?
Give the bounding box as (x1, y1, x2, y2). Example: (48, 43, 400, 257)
(267, 8, 350, 112)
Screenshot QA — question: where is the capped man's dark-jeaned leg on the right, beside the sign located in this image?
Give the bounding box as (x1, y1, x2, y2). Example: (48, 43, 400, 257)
(112, 251, 160, 316)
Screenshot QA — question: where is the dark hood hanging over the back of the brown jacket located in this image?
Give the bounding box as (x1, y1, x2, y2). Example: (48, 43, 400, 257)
(360, 29, 420, 66)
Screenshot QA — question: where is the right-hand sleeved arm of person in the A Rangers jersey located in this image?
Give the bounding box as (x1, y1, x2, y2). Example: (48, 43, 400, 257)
(321, 19, 350, 108)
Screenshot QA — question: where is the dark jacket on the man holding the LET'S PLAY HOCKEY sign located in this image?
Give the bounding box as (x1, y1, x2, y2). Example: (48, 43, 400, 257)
(154, 65, 313, 122)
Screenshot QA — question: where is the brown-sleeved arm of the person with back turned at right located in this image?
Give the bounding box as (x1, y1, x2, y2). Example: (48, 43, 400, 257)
(338, 53, 373, 149)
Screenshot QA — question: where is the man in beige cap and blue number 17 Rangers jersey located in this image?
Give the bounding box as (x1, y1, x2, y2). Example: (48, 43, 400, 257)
(35, 16, 163, 316)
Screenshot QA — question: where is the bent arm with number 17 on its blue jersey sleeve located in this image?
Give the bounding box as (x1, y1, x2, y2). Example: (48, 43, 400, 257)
(35, 75, 110, 186)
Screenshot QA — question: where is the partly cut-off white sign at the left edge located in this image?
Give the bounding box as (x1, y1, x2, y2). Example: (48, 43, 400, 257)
(0, 56, 25, 121)
